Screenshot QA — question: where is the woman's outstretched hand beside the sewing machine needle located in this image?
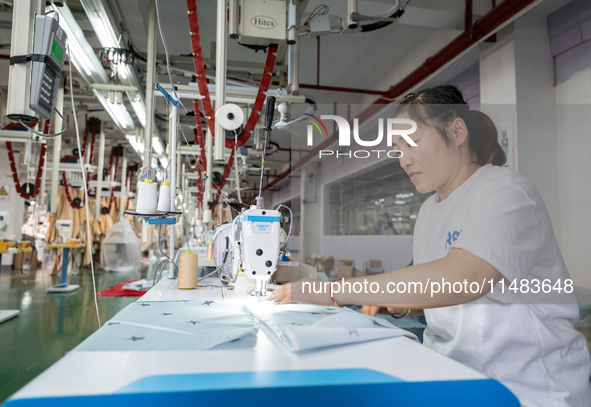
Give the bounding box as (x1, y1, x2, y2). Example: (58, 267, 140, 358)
(267, 279, 333, 305)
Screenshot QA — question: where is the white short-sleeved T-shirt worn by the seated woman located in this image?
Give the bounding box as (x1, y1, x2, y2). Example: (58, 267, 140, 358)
(413, 165, 591, 407)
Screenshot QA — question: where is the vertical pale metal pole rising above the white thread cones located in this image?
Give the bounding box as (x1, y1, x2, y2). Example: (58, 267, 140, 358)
(144, 0, 158, 166)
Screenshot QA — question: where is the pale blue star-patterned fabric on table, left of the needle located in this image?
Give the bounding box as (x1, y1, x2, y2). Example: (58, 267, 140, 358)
(74, 301, 257, 351)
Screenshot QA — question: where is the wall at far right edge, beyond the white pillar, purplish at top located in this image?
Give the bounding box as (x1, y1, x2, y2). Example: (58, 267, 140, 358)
(548, 1, 591, 291)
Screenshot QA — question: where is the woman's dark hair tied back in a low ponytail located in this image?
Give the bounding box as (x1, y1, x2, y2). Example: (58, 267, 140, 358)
(396, 85, 507, 165)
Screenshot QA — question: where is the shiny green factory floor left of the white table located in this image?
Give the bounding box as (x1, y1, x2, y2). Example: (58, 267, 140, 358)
(0, 266, 147, 403)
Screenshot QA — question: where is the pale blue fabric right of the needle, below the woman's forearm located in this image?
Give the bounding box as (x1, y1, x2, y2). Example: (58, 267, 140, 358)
(248, 303, 417, 351)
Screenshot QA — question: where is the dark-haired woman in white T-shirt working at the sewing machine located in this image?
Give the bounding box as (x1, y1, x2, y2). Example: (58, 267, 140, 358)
(270, 86, 591, 407)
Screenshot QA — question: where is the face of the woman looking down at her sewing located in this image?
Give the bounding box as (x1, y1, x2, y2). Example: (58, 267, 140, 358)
(392, 116, 463, 197)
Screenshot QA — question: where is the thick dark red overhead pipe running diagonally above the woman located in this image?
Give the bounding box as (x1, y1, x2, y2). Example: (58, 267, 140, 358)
(254, 0, 542, 198)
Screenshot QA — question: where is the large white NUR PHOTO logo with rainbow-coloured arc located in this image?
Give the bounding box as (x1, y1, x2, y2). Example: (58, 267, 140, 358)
(306, 114, 417, 158)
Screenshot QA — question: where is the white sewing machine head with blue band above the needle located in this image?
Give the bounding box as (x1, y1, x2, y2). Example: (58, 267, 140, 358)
(230, 205, 281, 296)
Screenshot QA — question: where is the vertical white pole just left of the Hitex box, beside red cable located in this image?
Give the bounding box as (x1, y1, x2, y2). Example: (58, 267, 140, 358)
(214, 0, 227, 163)
